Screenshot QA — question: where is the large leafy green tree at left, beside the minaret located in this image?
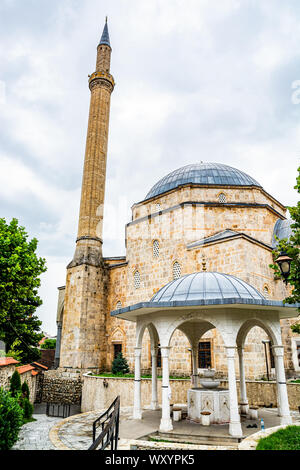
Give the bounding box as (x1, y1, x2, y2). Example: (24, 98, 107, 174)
(0, 219, 46, 363)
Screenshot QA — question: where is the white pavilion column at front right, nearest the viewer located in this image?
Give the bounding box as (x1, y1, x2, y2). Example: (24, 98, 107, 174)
(226, 346, 243, 437)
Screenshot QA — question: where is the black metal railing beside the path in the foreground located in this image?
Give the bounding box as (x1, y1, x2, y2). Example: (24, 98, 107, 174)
(88, 396, 120, 450)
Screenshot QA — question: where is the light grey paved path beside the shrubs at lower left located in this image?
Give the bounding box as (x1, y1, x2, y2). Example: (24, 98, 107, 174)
(12, 414, 61, 450)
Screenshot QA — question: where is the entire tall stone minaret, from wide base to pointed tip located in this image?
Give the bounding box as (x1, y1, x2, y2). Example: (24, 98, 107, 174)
(60, 19, 115, 370)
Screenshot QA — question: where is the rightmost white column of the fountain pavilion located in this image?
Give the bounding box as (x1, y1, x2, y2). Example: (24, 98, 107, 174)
(272, 345, 292, 425)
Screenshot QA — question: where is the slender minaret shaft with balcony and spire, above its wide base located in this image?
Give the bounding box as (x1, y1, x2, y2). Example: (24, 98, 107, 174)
(71, 22, 115, 266)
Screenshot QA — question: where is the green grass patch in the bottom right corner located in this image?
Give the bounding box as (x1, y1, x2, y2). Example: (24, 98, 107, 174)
(256, 426, 300, 450)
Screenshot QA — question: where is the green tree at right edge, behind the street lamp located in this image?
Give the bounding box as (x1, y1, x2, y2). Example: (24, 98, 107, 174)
(271, 167, 300, 333)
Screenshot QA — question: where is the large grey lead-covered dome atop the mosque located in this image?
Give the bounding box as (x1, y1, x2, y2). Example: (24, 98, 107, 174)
(145, 162, 261, 199)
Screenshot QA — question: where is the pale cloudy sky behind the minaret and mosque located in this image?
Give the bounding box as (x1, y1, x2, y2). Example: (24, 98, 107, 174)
(0, 0, 300, 334)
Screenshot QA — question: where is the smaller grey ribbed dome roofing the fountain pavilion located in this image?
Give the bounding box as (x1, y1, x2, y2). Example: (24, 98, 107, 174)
(151, 272, 266, 303)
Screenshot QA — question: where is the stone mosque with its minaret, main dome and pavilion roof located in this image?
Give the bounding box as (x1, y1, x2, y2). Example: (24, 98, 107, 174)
(56, 23, 300, 386)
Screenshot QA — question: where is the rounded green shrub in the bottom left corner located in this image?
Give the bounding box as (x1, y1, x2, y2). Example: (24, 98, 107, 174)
(0, 388, 23, 450)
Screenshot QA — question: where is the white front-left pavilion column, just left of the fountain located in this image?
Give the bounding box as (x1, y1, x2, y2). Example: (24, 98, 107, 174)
(159, 347, 173, 432)
